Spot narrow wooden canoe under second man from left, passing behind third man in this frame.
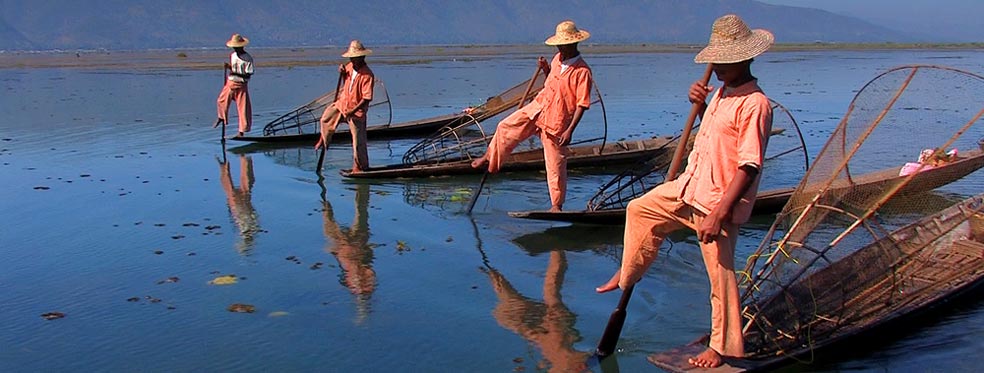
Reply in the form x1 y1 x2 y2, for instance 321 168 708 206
340 136 675 179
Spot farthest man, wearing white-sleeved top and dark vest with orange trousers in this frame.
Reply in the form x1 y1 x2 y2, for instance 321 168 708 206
212 34 253 136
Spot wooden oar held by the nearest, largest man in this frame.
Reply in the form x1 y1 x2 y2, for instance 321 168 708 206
595 64 711 358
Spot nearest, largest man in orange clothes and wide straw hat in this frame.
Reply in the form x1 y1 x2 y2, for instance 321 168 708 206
596 14 774 368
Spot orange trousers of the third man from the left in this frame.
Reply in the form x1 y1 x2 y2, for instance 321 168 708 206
486 110 568 207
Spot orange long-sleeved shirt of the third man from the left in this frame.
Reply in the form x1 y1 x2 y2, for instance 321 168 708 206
523 53 594 136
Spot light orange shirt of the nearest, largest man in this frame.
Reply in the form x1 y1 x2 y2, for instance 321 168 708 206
676 80 772 224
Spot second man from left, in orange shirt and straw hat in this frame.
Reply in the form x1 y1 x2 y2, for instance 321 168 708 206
314 40 376 173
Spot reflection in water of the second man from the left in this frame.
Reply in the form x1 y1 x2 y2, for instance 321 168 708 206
322 184 376 324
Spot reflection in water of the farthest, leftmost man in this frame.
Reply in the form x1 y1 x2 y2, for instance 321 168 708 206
218 154 260 255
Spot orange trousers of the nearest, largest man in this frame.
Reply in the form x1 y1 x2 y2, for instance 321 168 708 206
618 182 745 357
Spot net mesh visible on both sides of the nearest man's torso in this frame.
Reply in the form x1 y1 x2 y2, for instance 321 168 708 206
587 100 810 211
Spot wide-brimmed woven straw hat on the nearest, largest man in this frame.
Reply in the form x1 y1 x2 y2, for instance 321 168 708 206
694 14 775 63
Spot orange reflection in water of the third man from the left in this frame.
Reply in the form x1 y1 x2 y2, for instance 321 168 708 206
484 250 591 372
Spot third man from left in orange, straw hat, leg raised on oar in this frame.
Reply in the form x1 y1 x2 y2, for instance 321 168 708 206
471 20 594 211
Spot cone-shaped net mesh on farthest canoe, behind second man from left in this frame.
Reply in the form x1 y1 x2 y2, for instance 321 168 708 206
263 78 393 136
